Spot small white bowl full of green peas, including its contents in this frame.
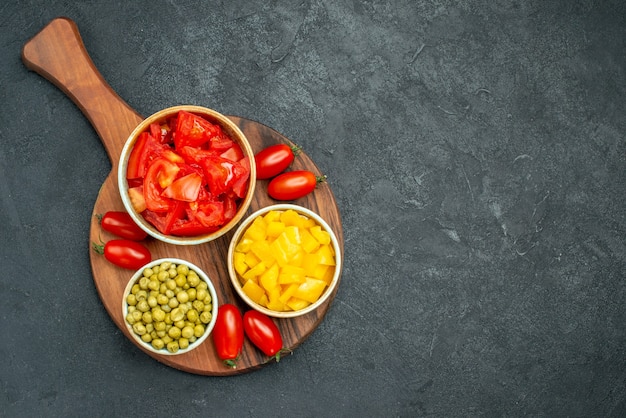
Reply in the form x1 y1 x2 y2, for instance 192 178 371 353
122 258 218 355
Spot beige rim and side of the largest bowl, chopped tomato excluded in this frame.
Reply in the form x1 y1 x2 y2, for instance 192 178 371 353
117 105 256 245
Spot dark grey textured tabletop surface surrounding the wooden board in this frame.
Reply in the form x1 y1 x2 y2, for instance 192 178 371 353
0 0 626 417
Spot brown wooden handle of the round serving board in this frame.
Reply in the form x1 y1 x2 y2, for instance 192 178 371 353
22 17 143 168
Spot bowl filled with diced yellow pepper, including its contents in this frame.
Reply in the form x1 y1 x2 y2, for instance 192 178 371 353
228 204 342 318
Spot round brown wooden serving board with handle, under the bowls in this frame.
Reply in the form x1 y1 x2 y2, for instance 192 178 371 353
22 18 344 375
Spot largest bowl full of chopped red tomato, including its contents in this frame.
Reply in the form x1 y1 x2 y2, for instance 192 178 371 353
118 105 256 245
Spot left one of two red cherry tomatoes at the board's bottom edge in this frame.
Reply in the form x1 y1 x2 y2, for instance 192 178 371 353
211 303 243 369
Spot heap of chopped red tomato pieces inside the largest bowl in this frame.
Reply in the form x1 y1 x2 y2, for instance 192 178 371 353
127 111 251 236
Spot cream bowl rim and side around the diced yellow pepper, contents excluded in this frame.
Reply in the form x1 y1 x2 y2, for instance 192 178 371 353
227 204 342 318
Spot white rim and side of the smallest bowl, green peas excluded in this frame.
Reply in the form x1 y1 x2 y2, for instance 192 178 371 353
122 258 218 355
